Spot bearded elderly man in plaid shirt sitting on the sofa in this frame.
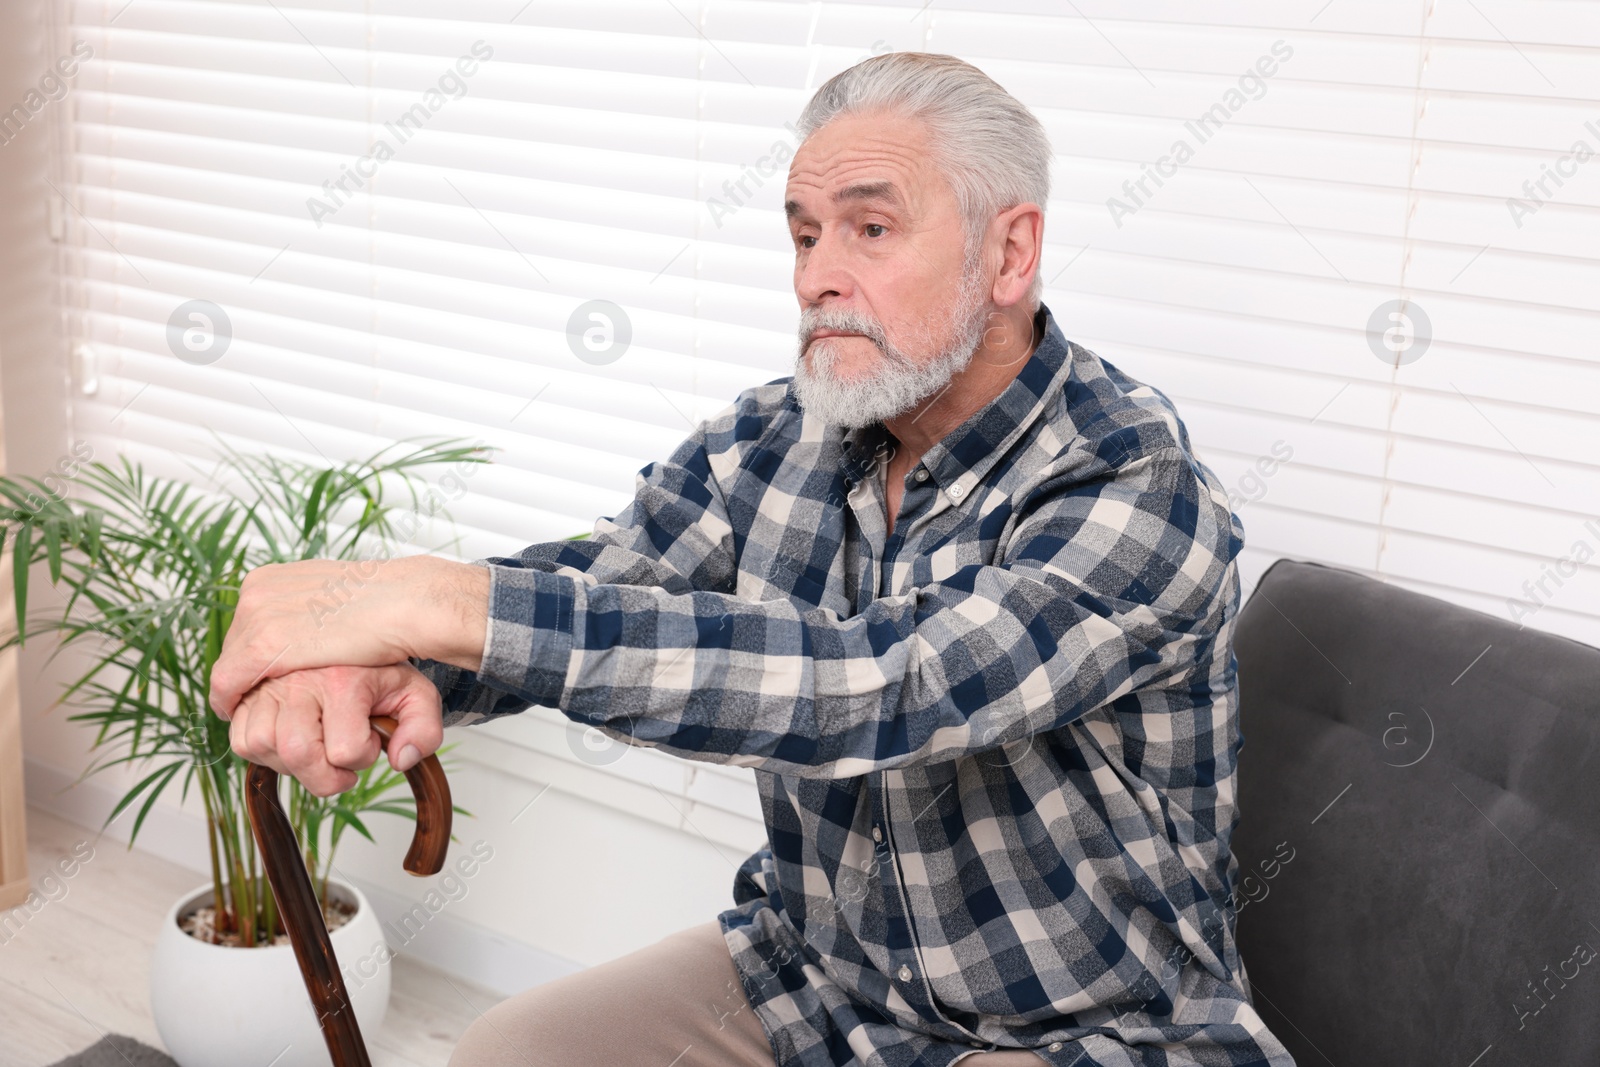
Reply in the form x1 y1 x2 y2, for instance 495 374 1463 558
213 53 1293 1067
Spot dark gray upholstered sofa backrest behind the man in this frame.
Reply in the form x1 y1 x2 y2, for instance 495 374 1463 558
1234 560 1600 1067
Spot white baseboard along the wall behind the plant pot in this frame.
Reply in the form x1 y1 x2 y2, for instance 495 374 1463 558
24 760 582 997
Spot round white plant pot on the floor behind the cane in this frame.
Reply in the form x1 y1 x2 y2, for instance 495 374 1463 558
150 878 389 1067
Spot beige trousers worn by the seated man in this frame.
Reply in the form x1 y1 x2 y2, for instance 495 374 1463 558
450 920 1045 1067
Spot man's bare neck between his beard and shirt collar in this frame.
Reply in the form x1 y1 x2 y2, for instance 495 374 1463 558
883 306 1038 477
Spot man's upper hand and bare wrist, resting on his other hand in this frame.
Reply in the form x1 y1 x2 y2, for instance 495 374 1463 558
211 555 490 718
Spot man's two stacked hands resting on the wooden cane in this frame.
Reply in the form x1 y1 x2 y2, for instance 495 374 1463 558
210 555 490 797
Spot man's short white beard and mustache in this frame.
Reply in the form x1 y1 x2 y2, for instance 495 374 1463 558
794 256 989 429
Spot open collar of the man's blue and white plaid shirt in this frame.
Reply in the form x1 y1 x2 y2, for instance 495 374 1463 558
840 302 1072 502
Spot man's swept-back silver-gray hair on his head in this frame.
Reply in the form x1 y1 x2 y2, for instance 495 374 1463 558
795 51 1051 309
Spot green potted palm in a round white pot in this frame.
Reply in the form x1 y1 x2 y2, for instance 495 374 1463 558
0 440 490 1067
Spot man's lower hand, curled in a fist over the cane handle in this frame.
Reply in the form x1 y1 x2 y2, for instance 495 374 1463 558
227 664 445 797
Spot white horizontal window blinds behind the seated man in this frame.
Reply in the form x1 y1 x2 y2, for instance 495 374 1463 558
62 0 1600 840
